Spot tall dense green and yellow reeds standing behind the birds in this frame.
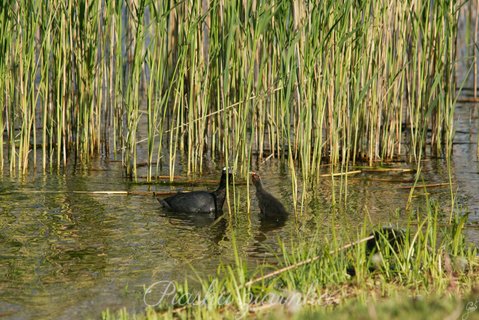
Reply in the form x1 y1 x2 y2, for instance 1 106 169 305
0 0 460 180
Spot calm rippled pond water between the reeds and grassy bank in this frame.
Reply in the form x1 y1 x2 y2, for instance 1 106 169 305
0 125 479 319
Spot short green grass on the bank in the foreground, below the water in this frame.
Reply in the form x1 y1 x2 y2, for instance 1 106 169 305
103 198 479 319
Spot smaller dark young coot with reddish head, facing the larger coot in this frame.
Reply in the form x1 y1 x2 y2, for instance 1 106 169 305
251 172 288 222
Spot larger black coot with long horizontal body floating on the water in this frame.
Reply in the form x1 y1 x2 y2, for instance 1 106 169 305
158 168 233 218
